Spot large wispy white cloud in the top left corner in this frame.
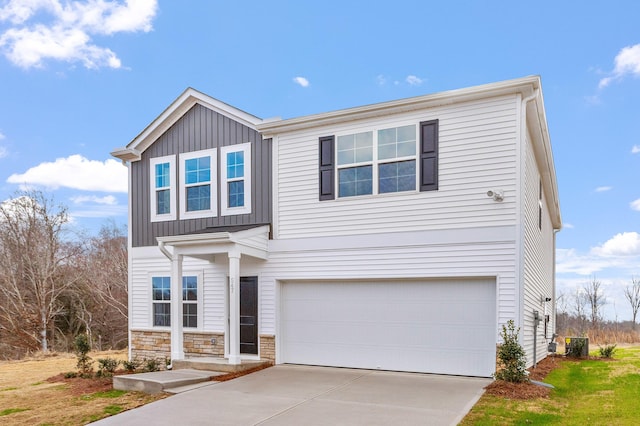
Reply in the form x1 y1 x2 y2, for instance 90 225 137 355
0 0 158 69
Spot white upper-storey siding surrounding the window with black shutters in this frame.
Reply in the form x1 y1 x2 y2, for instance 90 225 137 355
274 95 518 239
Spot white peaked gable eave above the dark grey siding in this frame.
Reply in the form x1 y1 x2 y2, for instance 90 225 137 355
111 87 262 162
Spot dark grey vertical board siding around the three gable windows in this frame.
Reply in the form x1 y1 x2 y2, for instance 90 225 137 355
129 104 272 247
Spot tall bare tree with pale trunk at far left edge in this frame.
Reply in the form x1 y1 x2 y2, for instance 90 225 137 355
0 191 82 352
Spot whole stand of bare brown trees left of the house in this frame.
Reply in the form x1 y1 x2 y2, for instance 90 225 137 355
0 191 128 359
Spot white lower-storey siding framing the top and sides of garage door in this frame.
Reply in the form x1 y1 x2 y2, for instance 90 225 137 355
255 226 517 343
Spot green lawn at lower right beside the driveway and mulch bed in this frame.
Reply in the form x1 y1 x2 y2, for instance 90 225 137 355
461 346 640 426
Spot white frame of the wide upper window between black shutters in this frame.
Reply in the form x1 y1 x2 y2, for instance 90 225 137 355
334 121 420 199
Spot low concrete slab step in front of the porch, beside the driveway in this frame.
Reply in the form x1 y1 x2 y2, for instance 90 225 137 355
113 369 220 393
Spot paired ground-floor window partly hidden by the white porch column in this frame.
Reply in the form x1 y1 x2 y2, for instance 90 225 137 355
151 275 198 328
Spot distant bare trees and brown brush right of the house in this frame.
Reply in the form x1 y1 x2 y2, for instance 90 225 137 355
556 276 640 343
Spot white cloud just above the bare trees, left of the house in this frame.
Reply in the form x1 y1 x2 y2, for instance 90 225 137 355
7 154 127 192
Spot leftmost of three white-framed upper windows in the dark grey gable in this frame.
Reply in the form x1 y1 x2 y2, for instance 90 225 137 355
150 156 176 222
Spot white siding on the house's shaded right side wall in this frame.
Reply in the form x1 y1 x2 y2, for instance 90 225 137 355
520 130 555 365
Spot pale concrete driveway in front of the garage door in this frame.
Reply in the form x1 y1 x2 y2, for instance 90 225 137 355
94 365 491 426
